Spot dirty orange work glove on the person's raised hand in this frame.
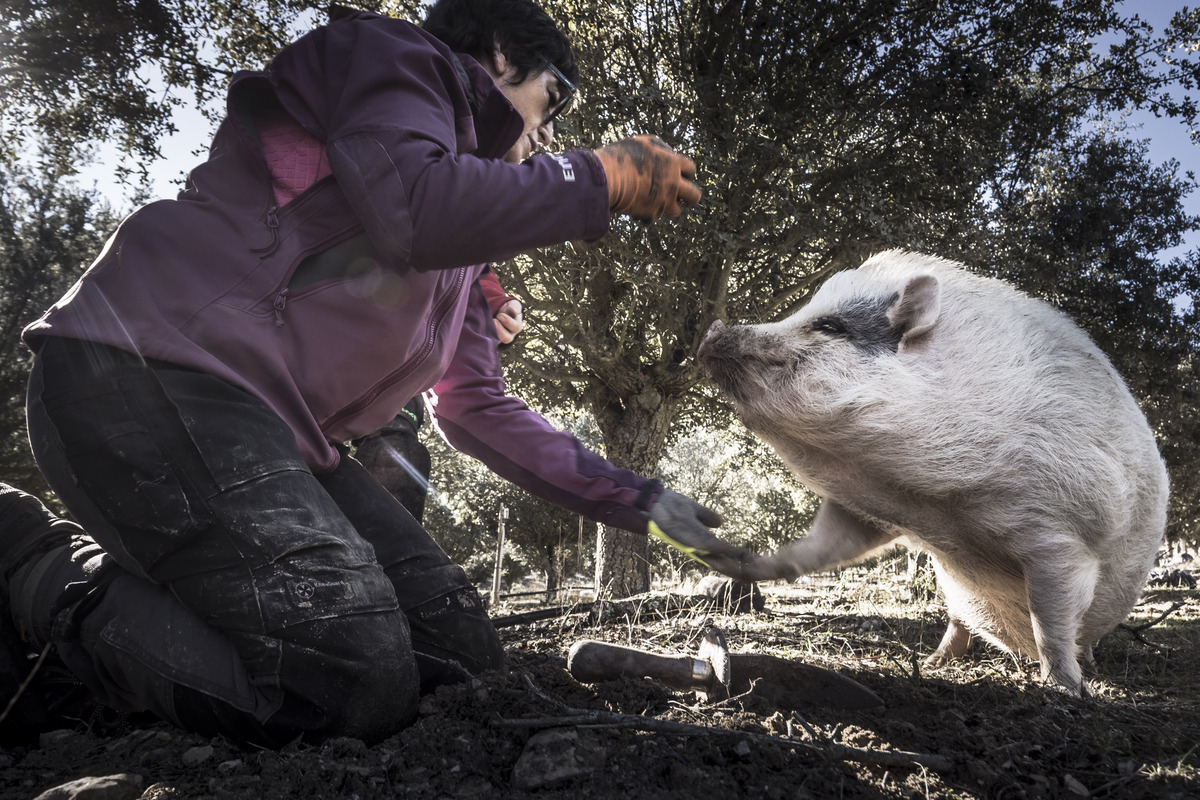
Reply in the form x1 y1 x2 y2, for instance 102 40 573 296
595 133 700 221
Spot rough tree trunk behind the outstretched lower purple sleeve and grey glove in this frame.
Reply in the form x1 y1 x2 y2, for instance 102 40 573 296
594 383 678 597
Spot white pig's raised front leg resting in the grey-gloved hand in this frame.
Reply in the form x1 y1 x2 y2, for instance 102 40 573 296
706 500 896 581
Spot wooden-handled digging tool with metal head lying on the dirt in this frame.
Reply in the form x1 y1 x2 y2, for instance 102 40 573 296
566 627 883 710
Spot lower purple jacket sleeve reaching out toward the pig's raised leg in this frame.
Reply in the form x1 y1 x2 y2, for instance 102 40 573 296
431 283 652 534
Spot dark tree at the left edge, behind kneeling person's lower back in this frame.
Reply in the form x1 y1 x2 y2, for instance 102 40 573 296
0 154 115 498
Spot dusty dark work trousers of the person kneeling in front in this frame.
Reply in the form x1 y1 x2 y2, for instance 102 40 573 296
29 338 503 745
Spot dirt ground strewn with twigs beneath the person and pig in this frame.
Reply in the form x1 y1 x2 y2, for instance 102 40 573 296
0 567 1200 800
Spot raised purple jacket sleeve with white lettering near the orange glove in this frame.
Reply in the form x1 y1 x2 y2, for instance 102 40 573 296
283 13 610 270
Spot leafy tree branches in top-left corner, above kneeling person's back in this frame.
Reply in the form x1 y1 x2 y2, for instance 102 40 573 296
0 0 421 179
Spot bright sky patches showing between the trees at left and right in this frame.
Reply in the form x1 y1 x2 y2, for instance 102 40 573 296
80 7 1200 260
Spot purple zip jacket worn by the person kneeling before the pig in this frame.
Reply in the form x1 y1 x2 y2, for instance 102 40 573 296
24 10 647 533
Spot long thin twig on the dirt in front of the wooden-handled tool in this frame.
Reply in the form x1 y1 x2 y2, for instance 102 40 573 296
492 709 954 772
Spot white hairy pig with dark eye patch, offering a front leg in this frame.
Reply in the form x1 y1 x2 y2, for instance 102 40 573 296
698 251 1168 694
